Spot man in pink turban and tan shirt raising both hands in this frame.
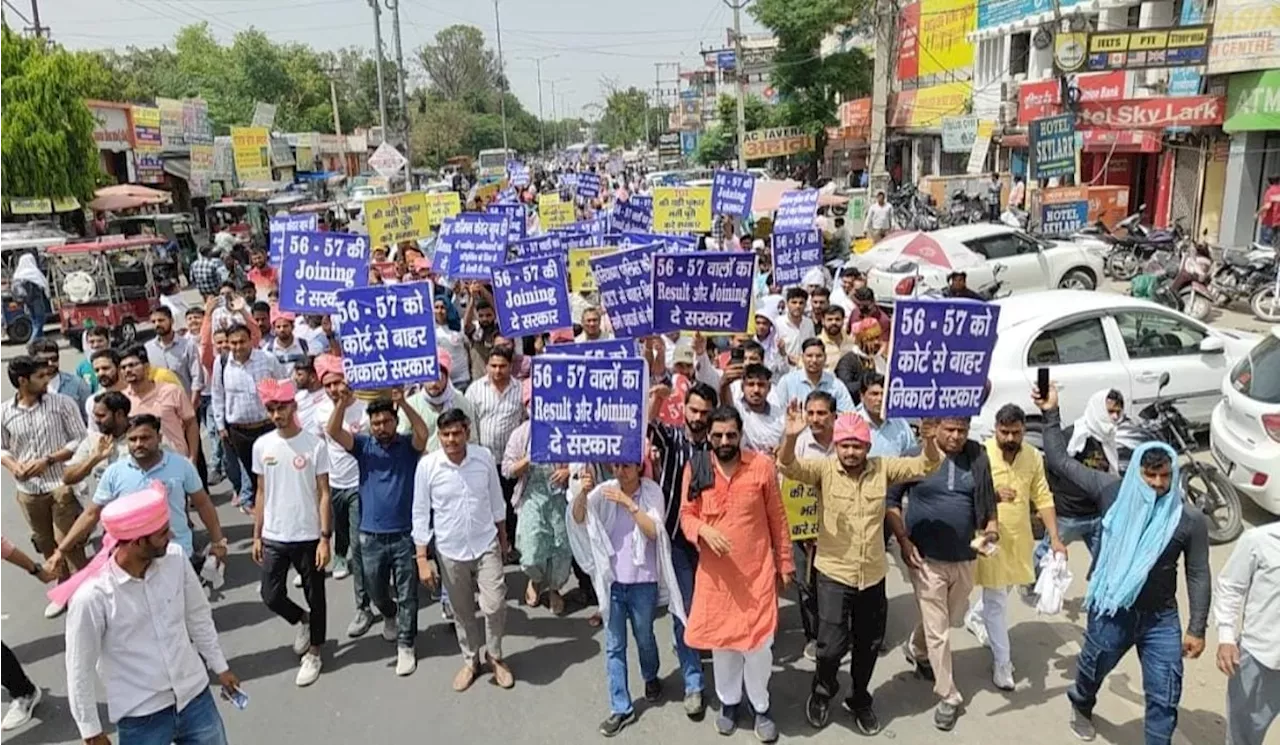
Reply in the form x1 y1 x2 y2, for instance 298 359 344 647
778 403 942 736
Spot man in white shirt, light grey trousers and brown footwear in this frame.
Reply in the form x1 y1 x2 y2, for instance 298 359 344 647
413 408 515 691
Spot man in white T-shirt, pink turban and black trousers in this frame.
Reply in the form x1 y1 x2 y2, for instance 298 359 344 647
253 380 333 686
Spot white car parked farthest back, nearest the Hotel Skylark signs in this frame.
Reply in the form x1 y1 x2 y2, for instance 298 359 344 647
855 223 1103 303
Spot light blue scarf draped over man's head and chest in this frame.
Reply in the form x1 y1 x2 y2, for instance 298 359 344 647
1084 442 1183 616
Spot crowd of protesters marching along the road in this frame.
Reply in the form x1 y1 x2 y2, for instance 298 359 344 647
0 175 1280 745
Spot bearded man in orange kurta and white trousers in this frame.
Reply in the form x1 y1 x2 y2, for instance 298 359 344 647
680 407 795 742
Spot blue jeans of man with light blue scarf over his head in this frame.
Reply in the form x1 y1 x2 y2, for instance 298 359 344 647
1066 608 1183 745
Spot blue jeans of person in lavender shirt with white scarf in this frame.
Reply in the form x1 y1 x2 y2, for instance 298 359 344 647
604 582 658 714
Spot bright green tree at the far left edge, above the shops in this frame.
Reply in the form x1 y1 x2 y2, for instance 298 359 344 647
0 27 104 202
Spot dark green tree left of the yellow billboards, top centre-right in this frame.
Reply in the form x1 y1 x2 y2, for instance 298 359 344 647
750 0 873 174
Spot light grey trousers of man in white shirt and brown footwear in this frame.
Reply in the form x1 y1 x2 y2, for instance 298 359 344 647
439 538 507 663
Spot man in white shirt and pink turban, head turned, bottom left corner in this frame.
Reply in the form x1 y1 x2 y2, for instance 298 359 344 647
67 489 239 745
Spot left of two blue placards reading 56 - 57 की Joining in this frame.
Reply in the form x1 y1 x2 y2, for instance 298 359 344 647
273 232 371 314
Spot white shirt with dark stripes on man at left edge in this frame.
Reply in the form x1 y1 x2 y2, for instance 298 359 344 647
0 393 86 494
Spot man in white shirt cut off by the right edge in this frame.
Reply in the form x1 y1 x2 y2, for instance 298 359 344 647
1213 522 1280 745
